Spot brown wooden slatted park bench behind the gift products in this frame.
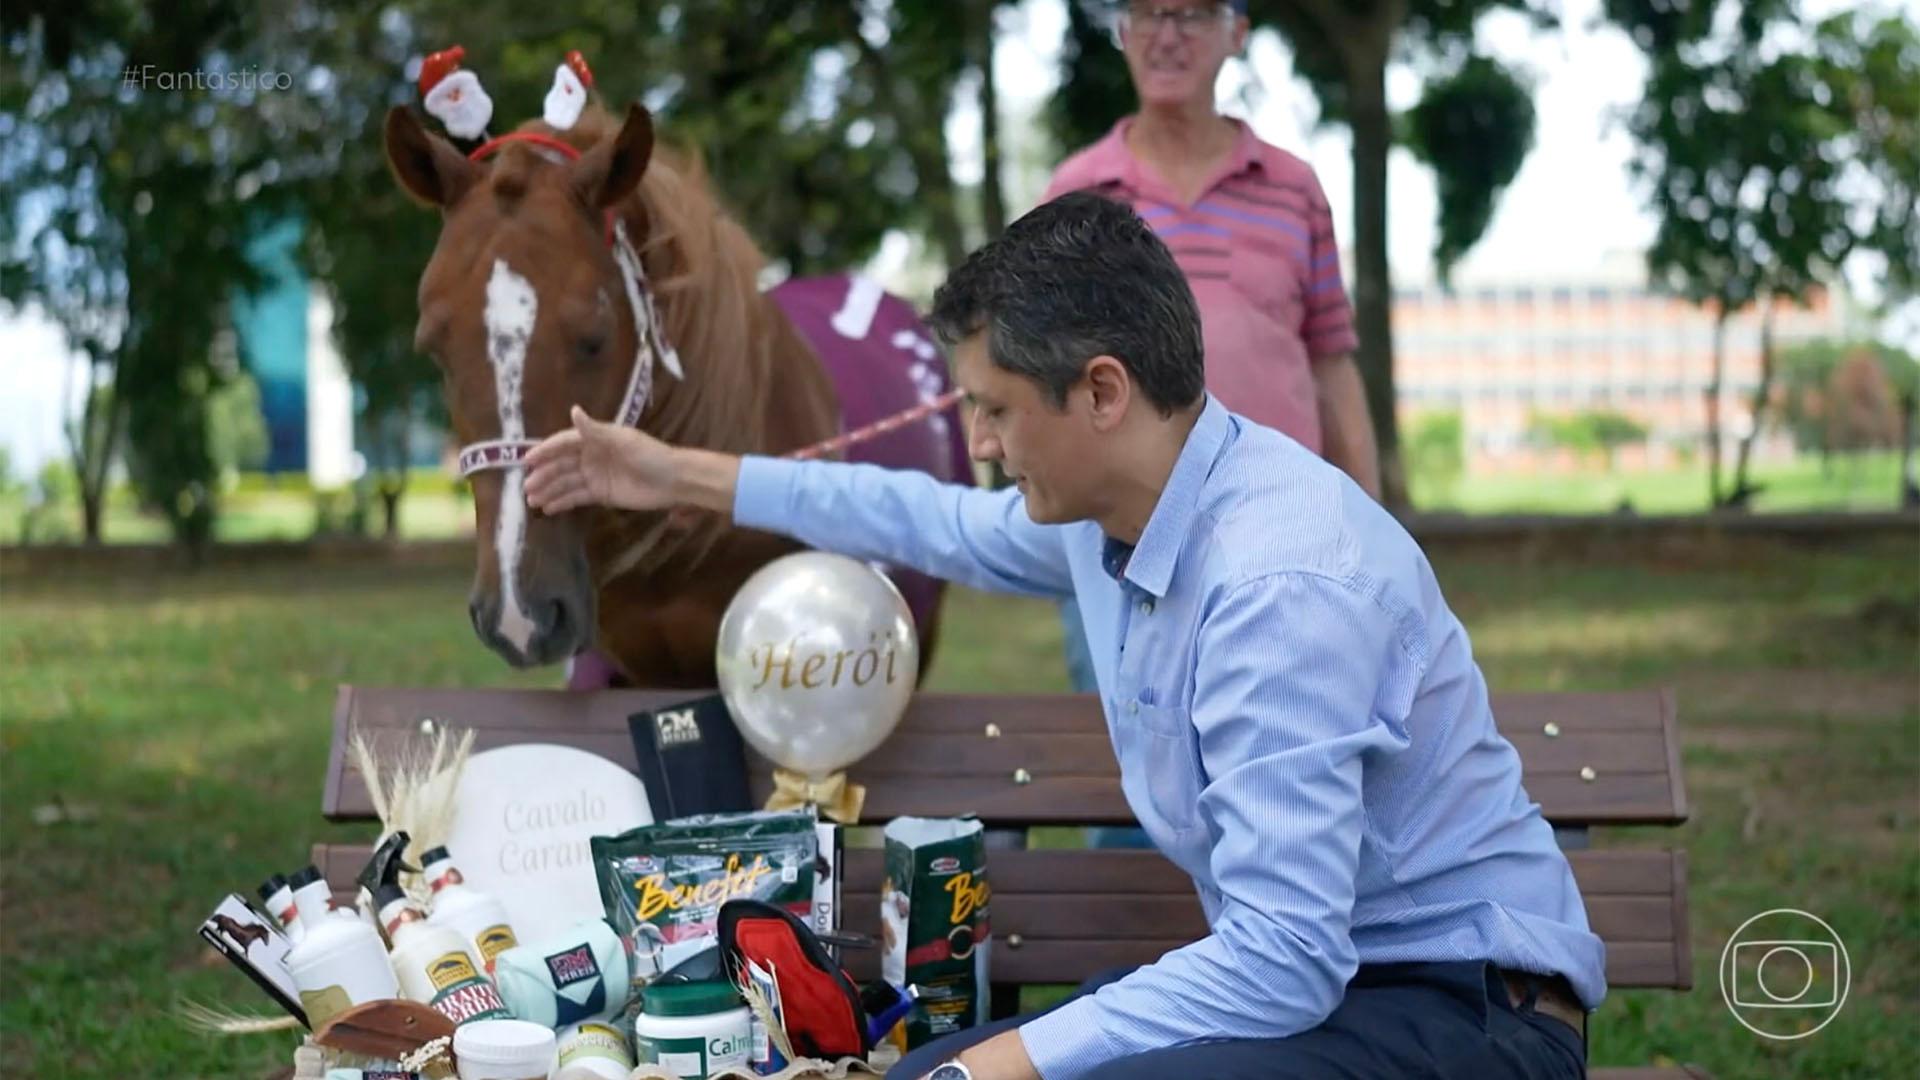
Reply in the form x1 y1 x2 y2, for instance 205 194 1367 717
313 686 1695 1080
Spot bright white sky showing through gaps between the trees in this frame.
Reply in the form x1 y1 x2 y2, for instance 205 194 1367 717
0 0 1920 473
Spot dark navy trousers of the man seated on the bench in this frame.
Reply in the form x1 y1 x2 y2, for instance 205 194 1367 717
887 963 1586 1080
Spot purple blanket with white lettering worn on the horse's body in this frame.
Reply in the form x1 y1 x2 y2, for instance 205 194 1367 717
568 275 973 690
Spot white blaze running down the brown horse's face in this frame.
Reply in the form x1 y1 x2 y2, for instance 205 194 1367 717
486 259 540 653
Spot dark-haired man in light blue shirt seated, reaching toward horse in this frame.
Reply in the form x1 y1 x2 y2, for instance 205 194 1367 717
526 196 1605 1080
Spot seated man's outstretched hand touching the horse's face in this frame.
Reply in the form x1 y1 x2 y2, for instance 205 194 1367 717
526 405 739 513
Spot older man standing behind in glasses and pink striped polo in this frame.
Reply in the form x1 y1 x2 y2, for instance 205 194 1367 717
1043 0 1380 834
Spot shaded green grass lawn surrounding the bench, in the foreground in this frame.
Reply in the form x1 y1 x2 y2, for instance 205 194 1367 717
0 542 1920 1078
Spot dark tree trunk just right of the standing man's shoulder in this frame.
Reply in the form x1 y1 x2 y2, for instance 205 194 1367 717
1346 34 1407 509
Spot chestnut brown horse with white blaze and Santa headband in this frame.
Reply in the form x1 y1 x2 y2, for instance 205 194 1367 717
386 104 966 688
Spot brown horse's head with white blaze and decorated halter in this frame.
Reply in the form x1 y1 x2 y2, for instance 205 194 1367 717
386 106 659 667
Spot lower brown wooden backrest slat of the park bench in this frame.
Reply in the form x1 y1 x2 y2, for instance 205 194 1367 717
313 844 1692 988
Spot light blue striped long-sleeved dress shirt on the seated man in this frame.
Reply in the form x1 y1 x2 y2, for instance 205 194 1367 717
735 398 1605 1080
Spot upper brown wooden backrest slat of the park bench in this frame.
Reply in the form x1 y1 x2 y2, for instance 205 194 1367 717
323 686 1686 826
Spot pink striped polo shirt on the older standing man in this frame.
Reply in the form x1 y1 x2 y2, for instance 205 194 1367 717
1041 117 1356 454
